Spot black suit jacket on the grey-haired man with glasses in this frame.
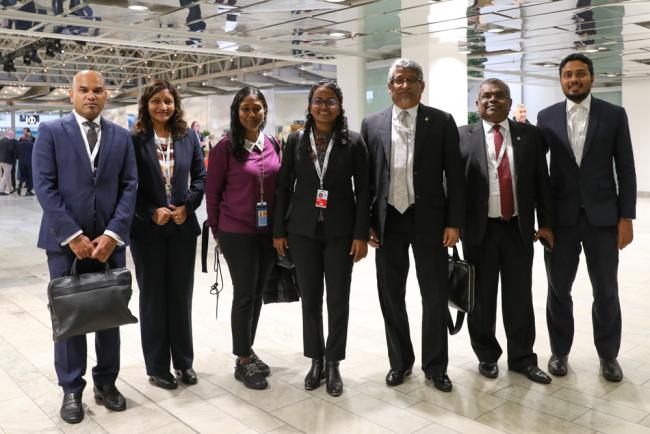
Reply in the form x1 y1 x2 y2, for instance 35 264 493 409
361 104 466 243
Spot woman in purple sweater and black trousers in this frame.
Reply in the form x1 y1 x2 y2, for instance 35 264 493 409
205 87 280 389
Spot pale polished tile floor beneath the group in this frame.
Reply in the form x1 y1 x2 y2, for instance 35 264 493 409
0 197 650 434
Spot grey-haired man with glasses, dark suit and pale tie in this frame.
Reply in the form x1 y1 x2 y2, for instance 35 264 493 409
361 59 465 392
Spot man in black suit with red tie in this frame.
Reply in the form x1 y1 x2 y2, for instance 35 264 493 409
459 78 553 384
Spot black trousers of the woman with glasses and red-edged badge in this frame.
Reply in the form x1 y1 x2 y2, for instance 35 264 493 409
289 228 353 362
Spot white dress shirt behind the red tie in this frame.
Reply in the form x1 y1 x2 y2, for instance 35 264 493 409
483 119 518 218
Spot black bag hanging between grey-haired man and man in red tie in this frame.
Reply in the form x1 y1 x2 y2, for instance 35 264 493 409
447 246 475 335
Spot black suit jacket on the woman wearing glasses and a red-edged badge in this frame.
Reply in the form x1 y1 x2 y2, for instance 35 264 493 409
273 131 369 240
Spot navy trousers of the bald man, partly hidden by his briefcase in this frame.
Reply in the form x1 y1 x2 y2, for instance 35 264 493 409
46 247 126 393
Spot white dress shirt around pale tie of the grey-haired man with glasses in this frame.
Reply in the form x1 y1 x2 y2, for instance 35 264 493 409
388 104 419 214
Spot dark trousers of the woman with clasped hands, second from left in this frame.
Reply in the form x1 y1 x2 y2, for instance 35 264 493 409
131 235 196 375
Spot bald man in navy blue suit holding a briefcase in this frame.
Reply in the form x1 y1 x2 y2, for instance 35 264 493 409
32 71 137 423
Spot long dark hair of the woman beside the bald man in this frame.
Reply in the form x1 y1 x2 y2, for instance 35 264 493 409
135 80 187 140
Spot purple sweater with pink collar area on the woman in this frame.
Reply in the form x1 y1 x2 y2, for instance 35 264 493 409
205 136 280 234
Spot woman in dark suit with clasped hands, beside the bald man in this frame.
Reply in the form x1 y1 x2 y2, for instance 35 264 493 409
131 80 206 389
